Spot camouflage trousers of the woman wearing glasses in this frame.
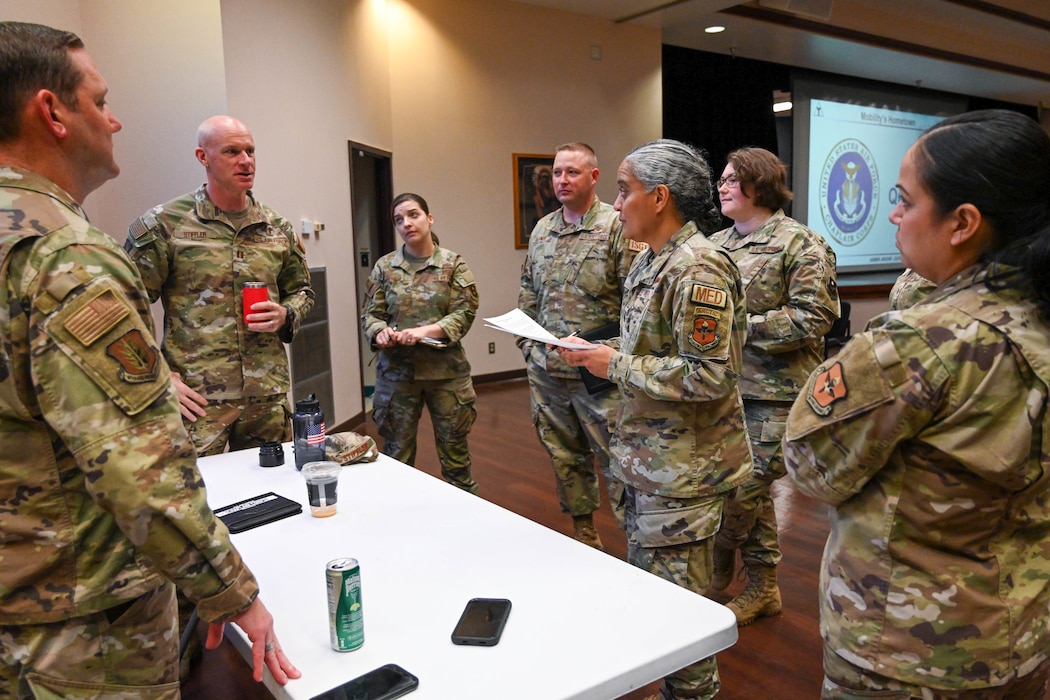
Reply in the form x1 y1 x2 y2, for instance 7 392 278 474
717 401 791 567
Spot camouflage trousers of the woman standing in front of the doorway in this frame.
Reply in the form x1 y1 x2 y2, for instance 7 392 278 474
372 377 478 493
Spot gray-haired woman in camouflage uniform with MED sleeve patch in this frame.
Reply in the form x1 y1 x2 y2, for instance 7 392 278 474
560 140 752 699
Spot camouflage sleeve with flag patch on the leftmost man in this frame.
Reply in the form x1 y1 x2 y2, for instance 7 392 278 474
30 246 258 621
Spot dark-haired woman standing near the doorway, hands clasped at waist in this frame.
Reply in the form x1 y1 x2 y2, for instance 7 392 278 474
361 193 478 493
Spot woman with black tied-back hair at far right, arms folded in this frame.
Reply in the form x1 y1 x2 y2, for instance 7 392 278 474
784 110 1050 700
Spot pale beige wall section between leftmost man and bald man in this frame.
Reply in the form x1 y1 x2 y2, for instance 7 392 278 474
0 0 226 240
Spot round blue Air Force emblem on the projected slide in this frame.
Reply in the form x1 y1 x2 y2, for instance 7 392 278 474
820 139 879 246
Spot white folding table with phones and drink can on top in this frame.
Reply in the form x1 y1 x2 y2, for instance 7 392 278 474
200 445 737 700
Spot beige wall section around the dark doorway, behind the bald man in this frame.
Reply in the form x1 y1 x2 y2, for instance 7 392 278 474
222 0 393 425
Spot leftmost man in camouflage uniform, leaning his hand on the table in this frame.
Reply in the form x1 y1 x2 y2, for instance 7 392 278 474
0 22 299 699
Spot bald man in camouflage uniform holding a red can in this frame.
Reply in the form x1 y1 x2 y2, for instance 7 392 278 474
124 116 314 455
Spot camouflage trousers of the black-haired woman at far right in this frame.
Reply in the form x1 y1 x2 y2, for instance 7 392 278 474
820 646 1050 700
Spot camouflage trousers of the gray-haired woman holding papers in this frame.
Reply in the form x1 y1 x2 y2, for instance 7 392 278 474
624 485 722 700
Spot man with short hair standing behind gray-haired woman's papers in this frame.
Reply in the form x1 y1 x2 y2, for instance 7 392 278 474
517 143 644 549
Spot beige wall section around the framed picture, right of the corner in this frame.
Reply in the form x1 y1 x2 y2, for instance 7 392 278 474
389 0 663 375
